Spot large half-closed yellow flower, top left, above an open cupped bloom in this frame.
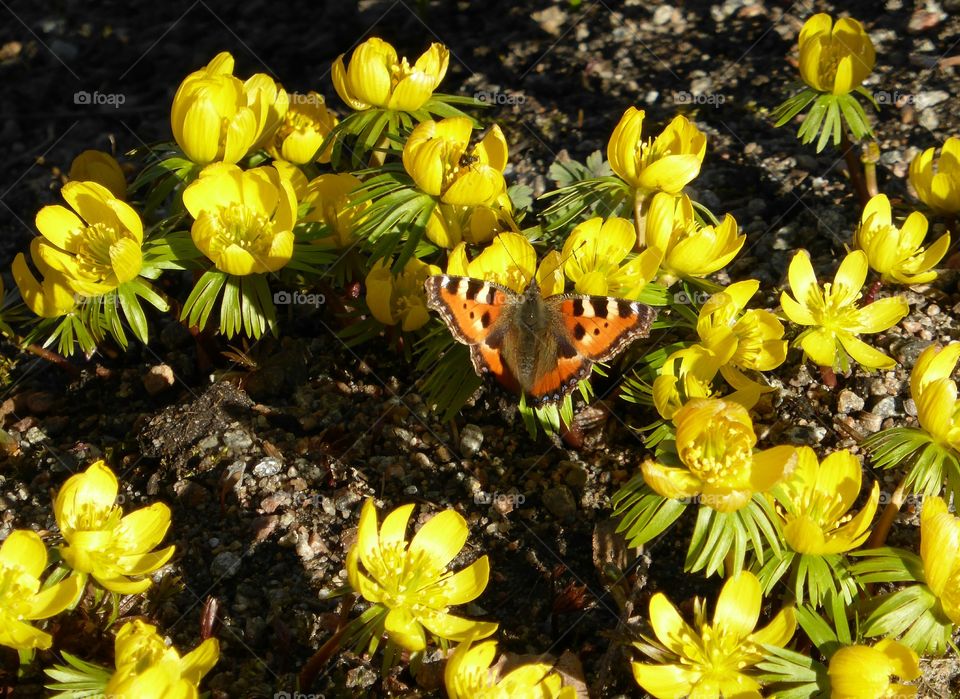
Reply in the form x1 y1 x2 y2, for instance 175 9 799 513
170 51 289 165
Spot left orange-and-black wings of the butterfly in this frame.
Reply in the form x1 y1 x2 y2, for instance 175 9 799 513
424 274 520 391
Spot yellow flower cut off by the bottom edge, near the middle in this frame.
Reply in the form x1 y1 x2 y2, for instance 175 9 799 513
443 639 576 699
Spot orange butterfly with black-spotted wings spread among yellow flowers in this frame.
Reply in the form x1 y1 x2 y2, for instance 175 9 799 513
424 274 657 406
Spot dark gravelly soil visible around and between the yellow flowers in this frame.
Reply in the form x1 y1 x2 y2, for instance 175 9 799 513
0 0 960 697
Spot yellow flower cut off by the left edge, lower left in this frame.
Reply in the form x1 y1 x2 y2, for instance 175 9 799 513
0 529 83 650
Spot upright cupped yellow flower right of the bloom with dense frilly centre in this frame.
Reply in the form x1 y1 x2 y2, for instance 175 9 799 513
774 447 880 556
